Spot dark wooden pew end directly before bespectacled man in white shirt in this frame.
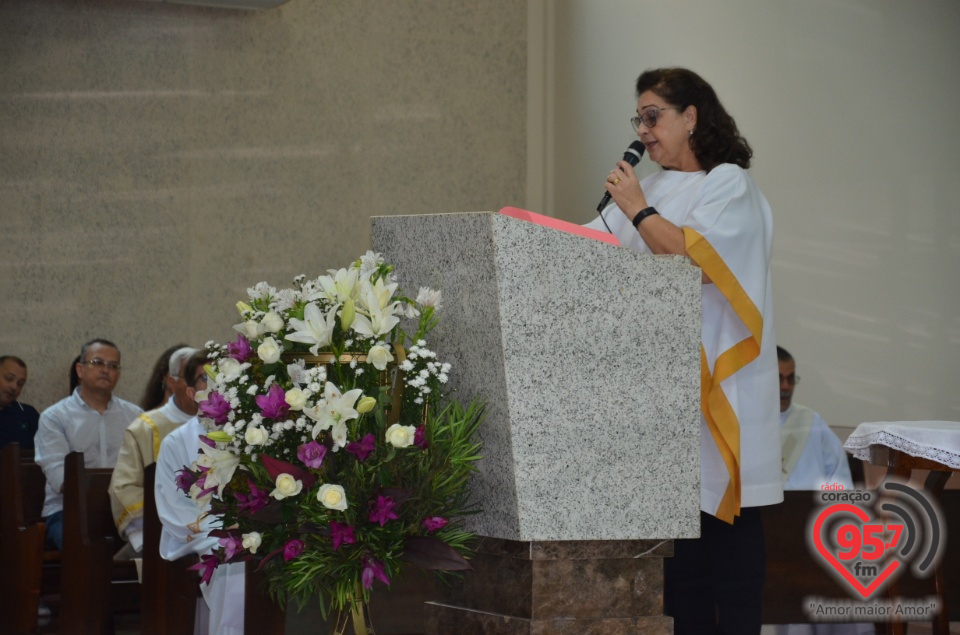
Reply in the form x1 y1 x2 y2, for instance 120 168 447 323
60 452 140 635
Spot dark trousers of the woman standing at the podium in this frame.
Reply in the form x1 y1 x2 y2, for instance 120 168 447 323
663 507 766 635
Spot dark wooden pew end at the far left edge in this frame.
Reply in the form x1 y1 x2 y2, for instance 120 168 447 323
0 443 60 634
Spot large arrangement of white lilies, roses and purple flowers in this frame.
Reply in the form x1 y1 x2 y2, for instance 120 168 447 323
178 252 483 632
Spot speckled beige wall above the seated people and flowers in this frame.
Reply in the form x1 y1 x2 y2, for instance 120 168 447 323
0 0 527 408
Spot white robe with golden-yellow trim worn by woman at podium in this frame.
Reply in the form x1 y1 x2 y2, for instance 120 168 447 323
588 164 783 522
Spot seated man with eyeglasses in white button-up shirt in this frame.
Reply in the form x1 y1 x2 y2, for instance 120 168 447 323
34 339 143 549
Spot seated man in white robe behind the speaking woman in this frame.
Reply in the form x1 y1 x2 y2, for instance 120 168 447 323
777 346 853 490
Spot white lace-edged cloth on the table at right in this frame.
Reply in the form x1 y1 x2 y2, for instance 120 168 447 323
843 421 960 470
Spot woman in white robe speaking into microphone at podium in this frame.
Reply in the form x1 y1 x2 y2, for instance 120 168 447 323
589 68 783 635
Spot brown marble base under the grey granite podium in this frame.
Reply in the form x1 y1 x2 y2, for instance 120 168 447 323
426 538 673 635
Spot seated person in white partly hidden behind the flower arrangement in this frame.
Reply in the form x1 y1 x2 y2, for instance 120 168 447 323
154 360 245 635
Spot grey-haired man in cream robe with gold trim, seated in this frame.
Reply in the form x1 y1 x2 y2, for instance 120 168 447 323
108 346 199 560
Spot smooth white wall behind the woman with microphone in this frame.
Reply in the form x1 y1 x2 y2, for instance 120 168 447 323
531 0 960 435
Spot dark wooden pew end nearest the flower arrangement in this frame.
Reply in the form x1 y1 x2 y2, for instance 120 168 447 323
140 464 199 635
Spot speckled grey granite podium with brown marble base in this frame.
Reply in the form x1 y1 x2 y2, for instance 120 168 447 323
373 212 701 635
